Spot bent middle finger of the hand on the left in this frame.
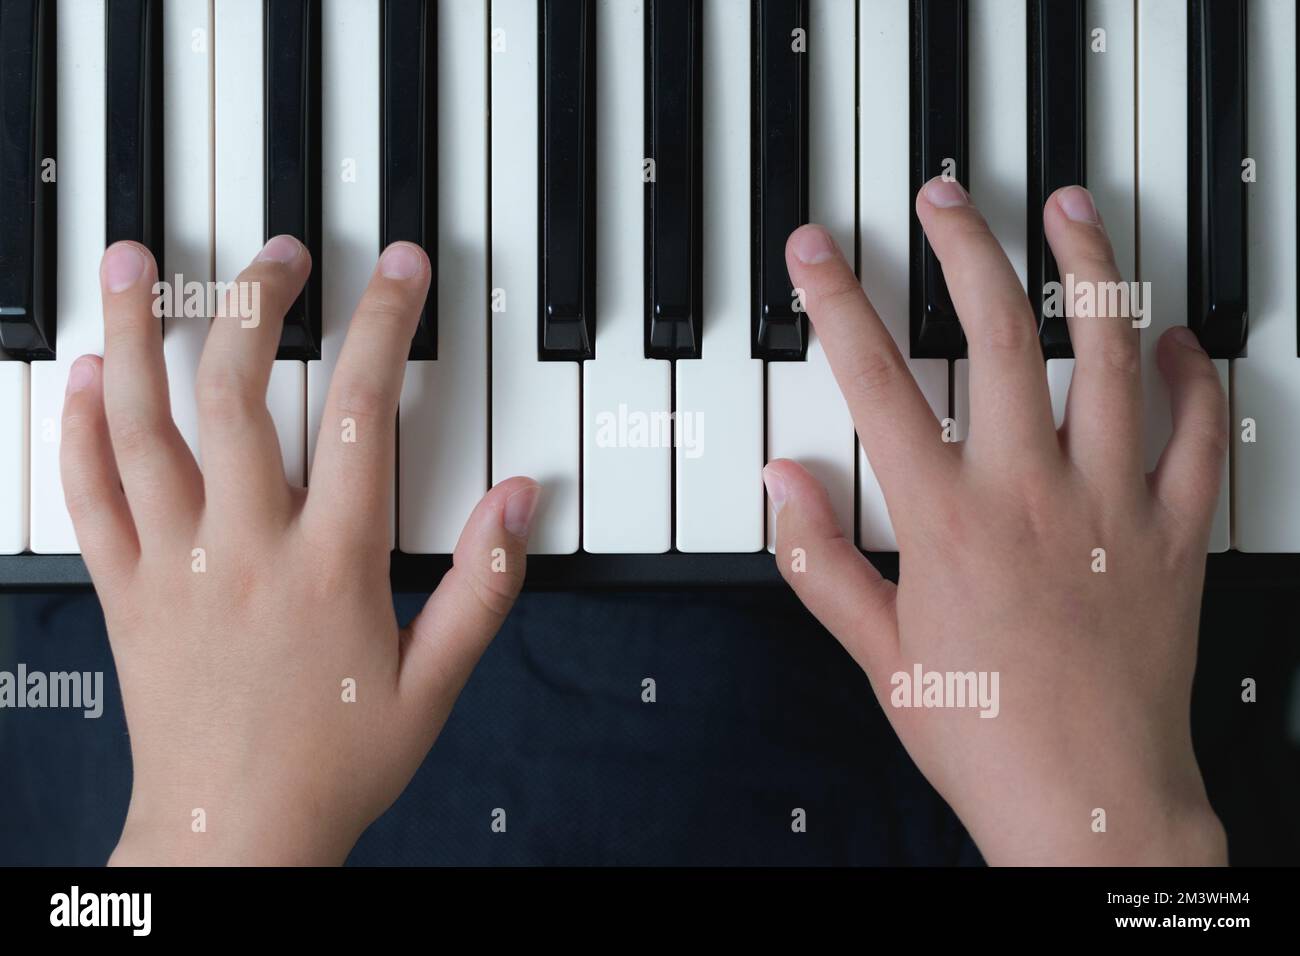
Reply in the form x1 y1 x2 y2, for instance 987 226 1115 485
195 235 312 515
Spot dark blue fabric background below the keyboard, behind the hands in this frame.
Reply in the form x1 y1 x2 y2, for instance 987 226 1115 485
0 591 1300 865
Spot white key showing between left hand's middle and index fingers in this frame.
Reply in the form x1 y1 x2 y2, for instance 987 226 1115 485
314 0 384 540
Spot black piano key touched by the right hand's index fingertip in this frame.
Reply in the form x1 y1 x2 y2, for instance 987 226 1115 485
750 0 809 362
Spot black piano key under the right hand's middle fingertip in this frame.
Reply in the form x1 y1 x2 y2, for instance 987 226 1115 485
911 0 970 359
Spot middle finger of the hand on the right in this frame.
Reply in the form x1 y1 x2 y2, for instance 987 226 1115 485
917 178 1060 460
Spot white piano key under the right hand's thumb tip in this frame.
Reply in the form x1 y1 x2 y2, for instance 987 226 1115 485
767 0 857 550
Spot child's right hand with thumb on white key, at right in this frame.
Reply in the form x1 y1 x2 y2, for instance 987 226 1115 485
764 181 1227 864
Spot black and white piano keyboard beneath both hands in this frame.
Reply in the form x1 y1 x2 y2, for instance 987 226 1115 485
0 0 1300 588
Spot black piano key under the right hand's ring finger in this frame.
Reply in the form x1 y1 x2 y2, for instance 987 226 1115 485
1027 0 1087 359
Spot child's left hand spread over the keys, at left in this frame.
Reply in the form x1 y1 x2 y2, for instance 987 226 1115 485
61 237 538 864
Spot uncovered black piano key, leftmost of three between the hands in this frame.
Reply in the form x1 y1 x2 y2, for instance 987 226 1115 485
537 0 595 362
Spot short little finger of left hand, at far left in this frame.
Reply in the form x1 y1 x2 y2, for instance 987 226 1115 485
59 355 139 582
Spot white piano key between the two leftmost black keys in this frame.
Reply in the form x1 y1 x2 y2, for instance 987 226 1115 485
30 0 105 554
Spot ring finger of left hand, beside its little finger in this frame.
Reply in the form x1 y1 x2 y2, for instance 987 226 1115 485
100 242 203 541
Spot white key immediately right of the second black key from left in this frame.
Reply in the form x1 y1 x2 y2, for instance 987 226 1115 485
159 0 212 455
